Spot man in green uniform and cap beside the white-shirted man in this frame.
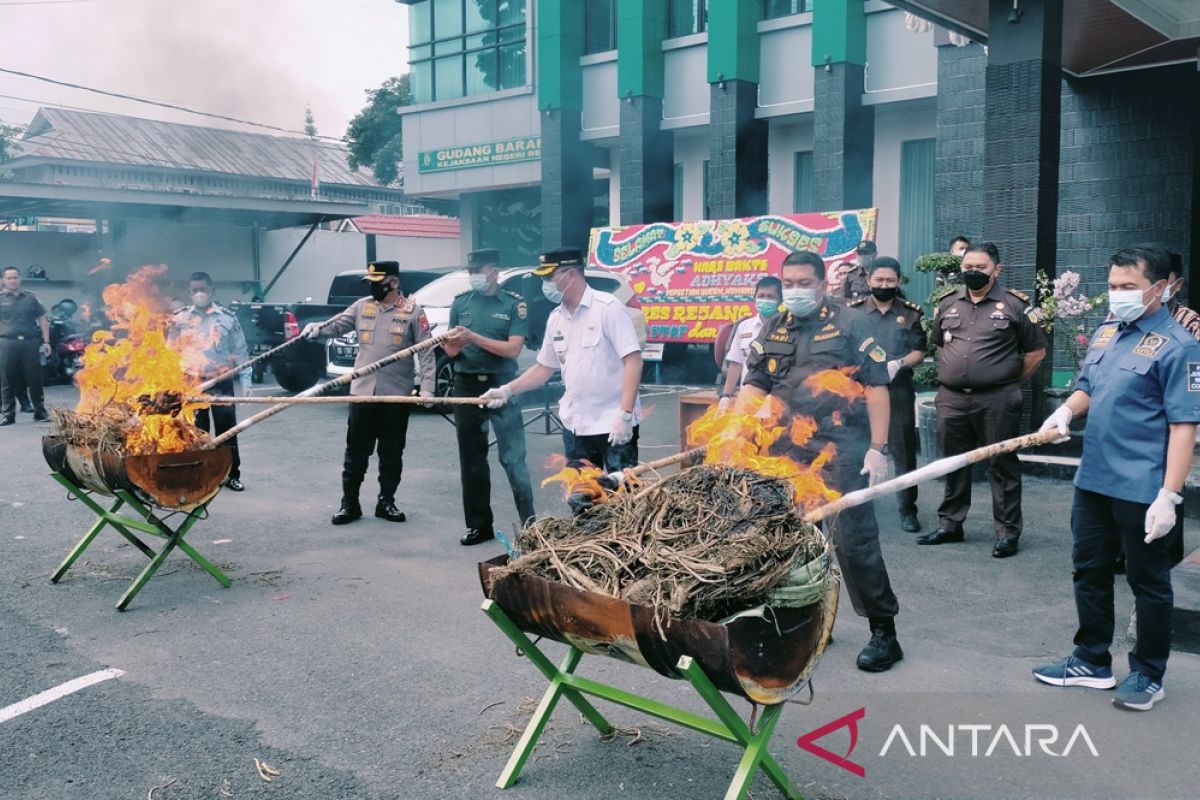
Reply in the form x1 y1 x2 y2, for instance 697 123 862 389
442 249 534 545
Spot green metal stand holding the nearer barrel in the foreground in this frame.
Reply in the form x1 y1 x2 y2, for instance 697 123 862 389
482 600 804 800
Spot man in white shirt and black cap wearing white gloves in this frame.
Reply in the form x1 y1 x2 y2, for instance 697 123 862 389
481 248 642 471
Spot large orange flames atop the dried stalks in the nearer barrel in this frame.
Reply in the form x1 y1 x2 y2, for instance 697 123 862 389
688 395 841 510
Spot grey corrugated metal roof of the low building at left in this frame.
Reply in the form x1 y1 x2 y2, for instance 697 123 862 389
10 108 379 186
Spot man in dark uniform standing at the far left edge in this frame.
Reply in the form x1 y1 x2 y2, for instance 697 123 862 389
0 266 50 425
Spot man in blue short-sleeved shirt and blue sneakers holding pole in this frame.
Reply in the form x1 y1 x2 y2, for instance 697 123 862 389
1033 248 1200 711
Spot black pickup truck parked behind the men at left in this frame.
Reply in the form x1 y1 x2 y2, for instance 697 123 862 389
229 270 446 392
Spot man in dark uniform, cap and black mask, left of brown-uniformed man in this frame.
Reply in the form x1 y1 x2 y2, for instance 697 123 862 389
850 255 925 533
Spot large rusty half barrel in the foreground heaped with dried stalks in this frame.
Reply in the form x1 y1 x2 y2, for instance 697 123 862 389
479 555 838 705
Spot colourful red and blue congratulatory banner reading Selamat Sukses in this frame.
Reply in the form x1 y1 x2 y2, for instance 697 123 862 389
588 209 877 343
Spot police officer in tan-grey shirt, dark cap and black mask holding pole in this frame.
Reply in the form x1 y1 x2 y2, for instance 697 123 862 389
304 261 434 525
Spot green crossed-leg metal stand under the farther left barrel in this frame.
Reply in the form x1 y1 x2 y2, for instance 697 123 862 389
50 473 232 612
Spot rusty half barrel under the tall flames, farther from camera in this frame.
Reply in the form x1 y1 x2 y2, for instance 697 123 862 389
42 435 233 511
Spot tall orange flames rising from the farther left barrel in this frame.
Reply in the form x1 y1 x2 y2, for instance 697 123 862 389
76 266 206 455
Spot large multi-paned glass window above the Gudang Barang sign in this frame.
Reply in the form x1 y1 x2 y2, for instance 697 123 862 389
408 0 527 103
